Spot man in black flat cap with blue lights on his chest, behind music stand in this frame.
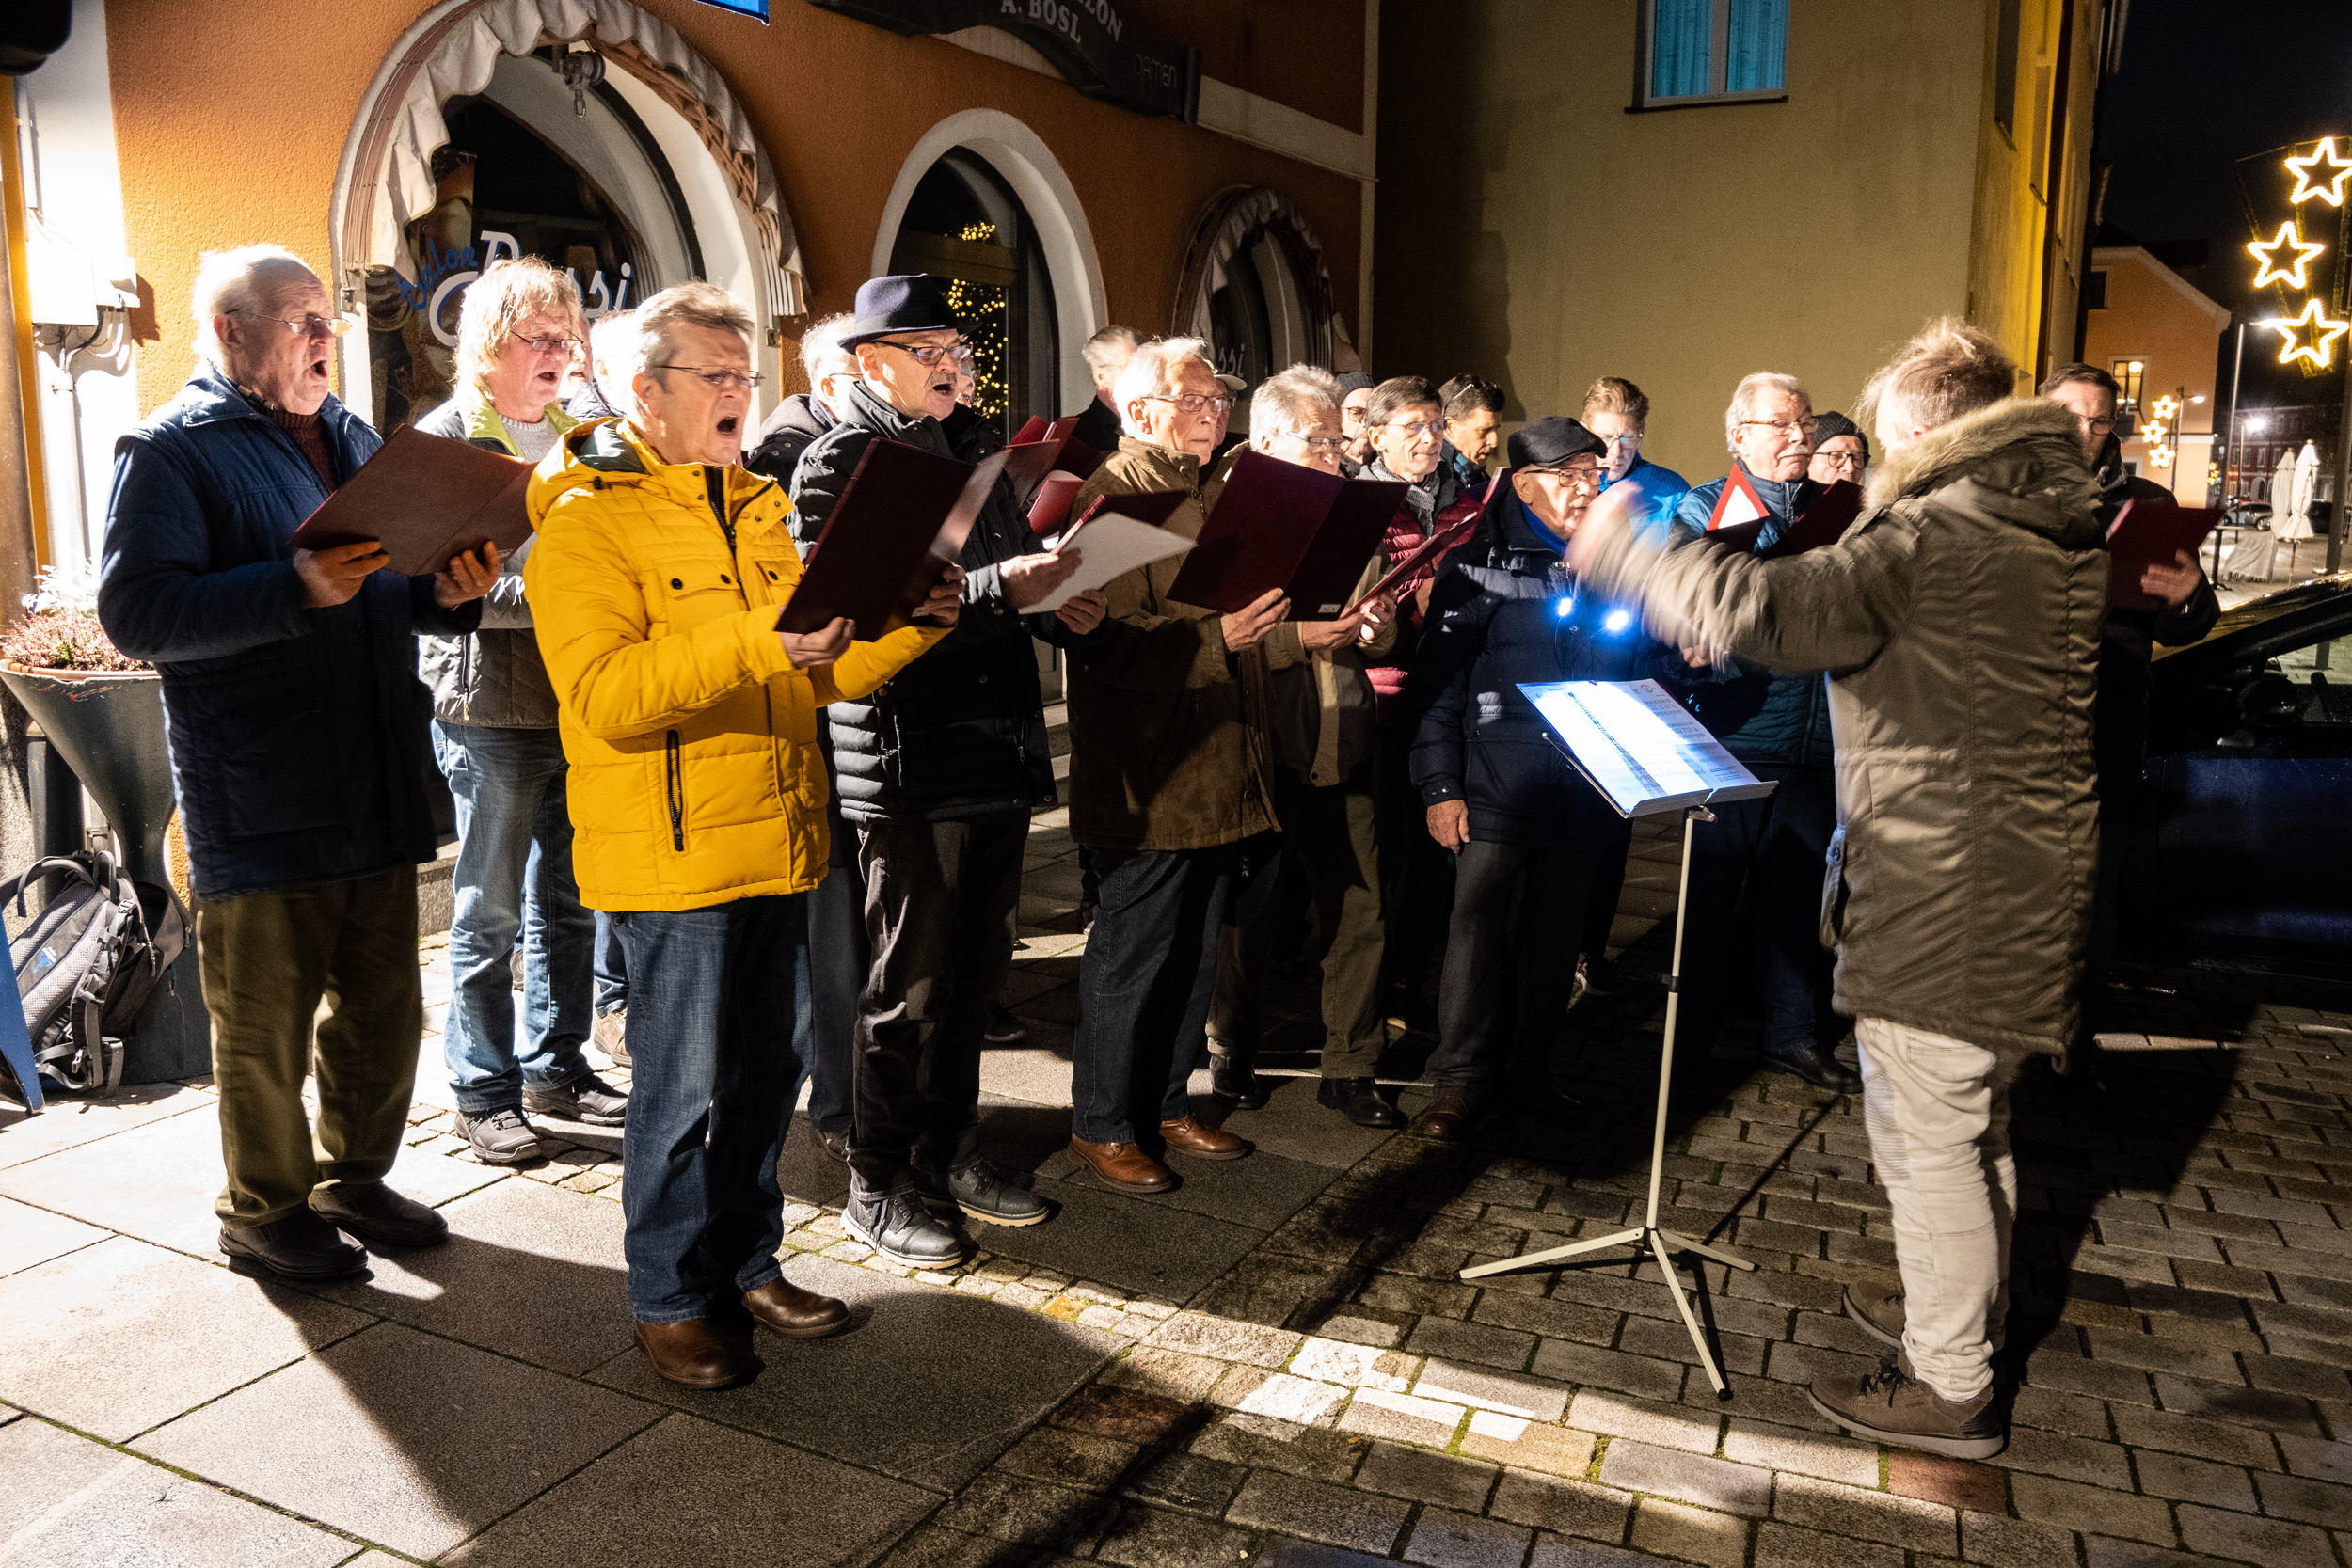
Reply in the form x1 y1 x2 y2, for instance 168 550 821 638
1406 416 1684 1138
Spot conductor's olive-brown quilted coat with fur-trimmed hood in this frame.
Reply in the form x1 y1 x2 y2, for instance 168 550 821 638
1588 400 2107 1051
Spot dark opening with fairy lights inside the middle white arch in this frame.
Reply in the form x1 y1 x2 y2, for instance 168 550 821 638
889 148 1061 439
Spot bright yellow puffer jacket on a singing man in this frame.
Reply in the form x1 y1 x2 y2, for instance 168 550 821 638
522 419 946 910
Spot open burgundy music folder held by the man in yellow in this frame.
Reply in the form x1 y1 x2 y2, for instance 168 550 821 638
776 439 1005 641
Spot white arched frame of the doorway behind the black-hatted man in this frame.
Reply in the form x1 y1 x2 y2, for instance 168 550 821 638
870 108 1110 416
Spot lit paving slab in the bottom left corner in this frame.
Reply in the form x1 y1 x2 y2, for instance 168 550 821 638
0 1420 355 1568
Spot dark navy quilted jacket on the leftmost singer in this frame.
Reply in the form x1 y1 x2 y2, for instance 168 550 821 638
99 364 483 898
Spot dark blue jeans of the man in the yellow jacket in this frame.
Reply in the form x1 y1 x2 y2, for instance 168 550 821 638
612 894 809 1323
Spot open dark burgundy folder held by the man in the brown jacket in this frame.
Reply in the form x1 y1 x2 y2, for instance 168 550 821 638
1169 451 1406 621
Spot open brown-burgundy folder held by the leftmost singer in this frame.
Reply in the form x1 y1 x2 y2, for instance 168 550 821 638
290 425 532 576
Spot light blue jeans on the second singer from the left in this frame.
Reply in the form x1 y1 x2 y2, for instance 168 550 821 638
433 721 596 1117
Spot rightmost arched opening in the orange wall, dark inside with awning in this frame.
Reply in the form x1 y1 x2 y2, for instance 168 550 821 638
1169 188 1359 428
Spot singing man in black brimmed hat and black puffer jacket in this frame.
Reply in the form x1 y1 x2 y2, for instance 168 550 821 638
793 275 1104 1267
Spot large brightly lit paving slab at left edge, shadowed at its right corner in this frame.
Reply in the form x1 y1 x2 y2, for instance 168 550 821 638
0 1237 370 1441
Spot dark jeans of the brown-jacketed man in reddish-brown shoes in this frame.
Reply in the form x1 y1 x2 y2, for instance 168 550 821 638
1071 844 1237 1143
